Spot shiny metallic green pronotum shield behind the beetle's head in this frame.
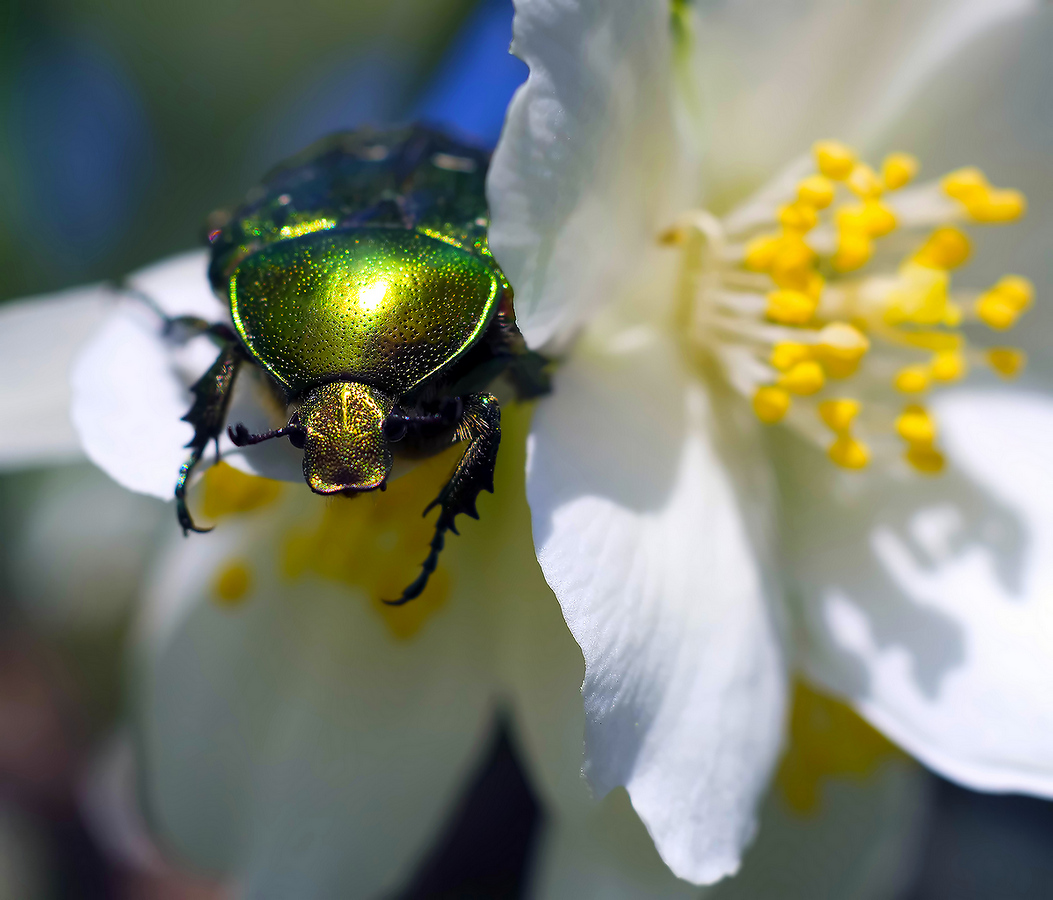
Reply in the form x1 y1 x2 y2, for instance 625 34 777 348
231 227 505 395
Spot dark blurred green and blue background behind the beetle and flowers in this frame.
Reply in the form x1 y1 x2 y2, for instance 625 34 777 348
0 0 1053 900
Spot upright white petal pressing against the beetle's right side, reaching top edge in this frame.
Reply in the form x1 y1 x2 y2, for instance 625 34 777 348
488 0 695 347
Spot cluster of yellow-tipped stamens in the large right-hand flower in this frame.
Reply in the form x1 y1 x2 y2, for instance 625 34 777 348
662 141 1033 474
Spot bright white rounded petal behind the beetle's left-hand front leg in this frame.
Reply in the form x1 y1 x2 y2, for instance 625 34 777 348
73 253 302 498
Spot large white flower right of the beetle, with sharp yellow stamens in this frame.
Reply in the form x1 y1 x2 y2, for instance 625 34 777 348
490 0 1053 882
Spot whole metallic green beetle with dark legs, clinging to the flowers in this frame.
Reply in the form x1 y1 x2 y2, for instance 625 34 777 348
167 126 548 604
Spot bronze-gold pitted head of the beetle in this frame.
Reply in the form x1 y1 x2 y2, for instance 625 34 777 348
297 381 395 494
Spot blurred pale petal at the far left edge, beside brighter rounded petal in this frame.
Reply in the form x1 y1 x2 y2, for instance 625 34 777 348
0 285 114 466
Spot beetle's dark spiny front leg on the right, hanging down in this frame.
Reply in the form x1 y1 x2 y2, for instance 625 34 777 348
384 394 501 606
